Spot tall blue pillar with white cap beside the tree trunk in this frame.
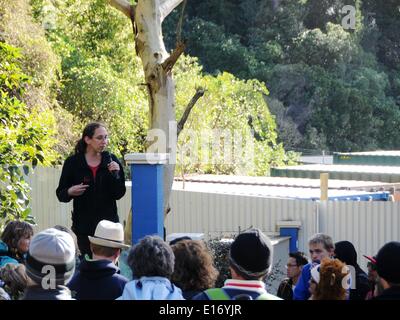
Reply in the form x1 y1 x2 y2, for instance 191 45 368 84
125 153 168 244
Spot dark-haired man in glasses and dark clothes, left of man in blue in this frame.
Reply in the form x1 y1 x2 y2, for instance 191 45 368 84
277 252 308 300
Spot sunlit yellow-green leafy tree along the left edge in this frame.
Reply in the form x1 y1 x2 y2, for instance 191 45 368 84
0 0 71 229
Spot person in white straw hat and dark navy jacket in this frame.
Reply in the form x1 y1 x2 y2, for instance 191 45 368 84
68 220 129 300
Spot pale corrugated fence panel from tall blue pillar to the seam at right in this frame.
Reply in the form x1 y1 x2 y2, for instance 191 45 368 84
166 190 316 250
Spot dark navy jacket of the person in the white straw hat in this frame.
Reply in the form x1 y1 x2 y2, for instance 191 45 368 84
68 259 129 300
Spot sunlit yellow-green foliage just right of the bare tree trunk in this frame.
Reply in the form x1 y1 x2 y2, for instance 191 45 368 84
175 56 293 175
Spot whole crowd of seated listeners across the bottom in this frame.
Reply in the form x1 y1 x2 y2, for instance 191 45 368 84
0 220 400 300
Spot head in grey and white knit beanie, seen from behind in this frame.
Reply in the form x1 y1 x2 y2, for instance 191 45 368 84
26 228 75 285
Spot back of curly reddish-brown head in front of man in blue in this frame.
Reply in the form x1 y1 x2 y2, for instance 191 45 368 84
311 258 350 300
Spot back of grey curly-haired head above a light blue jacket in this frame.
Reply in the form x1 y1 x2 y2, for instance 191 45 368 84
128 236 175 279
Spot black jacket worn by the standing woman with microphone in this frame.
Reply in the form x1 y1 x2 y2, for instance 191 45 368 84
56 152 126 235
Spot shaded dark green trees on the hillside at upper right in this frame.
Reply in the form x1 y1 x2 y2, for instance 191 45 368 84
164 0 400 151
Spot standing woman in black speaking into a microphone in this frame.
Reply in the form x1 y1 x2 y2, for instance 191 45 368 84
56 122 126 256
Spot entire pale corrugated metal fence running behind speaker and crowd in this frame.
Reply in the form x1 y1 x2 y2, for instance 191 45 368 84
28 167 400 266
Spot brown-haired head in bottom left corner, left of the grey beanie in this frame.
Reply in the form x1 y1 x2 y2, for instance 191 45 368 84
0 263 29 299
